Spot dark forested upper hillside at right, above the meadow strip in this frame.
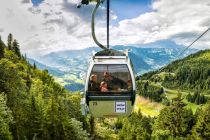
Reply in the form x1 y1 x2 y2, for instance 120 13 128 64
139 50 210 94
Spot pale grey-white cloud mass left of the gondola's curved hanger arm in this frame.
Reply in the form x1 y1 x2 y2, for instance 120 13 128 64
0 0 101 57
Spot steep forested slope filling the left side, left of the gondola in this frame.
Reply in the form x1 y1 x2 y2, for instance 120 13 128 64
0 34 89 140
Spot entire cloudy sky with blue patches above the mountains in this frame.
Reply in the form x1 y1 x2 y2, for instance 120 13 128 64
0 0 210 58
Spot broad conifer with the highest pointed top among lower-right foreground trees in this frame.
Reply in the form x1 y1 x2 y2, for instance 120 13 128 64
152 95 193 139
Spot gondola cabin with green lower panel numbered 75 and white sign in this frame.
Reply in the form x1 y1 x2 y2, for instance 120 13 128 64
85 50 136 117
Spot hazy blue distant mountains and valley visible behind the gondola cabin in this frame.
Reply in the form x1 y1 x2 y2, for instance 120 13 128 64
28 41 197 90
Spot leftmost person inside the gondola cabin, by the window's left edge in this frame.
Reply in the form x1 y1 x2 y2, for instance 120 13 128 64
88 74 100 91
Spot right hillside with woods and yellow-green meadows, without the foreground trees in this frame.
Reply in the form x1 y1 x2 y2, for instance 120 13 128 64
136 50 210 116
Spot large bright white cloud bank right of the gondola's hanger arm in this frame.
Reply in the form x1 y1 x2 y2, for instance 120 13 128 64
108 0 210 48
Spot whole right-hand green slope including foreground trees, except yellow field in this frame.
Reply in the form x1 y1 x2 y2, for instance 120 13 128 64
121 50 210 140
